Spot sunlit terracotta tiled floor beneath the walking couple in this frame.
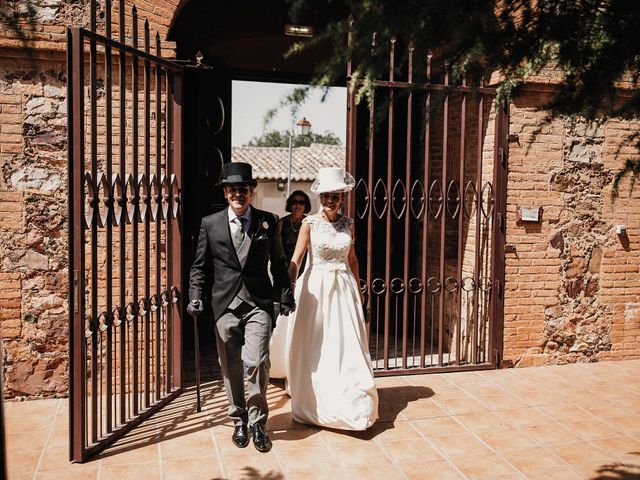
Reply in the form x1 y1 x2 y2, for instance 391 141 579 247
7 360 640 480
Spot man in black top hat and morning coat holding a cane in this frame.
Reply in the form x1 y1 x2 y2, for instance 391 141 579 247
187 162 295 452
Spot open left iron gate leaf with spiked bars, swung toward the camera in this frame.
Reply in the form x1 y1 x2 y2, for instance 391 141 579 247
67 0 182 462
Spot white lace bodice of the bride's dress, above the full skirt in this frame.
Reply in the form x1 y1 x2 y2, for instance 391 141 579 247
302 215 353 267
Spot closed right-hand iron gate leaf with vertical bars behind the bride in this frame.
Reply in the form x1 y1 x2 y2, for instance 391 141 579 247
347 39 508 375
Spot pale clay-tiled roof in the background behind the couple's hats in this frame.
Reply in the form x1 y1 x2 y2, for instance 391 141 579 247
231 143 345 181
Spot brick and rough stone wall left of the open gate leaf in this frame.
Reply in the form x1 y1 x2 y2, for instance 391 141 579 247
0 0 177 396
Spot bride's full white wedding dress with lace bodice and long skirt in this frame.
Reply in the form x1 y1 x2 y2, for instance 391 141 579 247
270 216 378 430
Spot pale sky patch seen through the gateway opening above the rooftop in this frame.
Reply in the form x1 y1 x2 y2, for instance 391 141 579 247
231 81 347 147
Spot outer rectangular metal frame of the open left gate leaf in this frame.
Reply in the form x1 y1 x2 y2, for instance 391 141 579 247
67 7 186 462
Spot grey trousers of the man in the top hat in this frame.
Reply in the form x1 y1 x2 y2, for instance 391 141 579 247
216 297 271 426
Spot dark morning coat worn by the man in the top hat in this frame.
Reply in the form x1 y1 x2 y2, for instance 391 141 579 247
189 206 294 323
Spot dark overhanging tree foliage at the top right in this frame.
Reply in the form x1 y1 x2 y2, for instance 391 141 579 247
290 0 640 195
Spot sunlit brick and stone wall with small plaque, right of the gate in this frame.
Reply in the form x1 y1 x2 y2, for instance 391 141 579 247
504 88 640 366
